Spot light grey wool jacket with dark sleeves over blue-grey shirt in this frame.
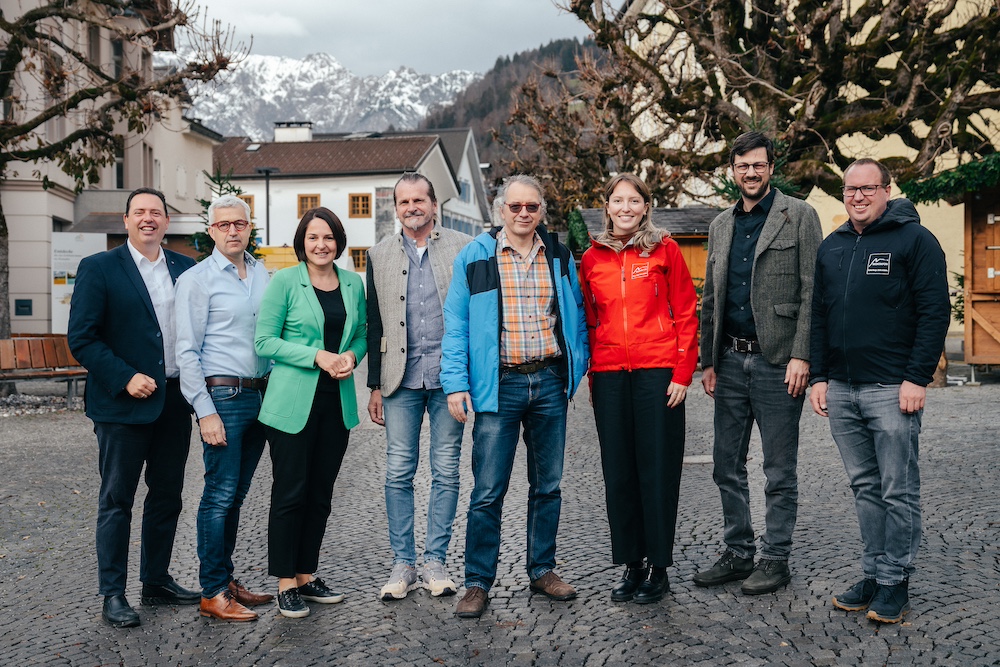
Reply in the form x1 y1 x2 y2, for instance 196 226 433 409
368 224 472 396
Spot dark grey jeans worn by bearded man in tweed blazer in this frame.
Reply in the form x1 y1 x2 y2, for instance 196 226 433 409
712 349 805 560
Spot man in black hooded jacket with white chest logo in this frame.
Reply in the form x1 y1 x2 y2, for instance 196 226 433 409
809 159 951 623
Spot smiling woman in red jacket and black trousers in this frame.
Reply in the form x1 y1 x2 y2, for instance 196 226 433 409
581 174 698 603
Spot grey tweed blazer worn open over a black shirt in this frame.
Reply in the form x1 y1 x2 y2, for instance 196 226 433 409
701 190 823 368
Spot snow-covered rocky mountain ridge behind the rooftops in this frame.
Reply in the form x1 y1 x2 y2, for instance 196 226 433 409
170 53 481 141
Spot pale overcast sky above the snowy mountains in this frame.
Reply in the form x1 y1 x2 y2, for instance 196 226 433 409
198 0 590 75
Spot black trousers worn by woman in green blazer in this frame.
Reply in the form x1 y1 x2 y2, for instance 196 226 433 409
267 391 350 577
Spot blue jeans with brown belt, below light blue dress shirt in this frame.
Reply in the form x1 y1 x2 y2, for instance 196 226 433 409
198 387 264 598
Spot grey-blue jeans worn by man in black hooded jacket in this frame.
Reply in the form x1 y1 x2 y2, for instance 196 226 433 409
827 380 922 586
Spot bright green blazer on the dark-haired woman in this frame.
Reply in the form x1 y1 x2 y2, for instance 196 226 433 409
254 262 368 433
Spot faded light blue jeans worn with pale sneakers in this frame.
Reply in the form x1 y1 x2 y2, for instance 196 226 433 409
382 387 465 565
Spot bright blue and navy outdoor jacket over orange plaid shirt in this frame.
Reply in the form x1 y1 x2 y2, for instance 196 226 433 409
441 225 588 412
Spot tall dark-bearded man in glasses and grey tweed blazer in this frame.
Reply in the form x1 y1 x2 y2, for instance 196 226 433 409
694 132 823 595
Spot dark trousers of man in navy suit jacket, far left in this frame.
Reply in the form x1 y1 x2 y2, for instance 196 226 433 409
94 381 191 595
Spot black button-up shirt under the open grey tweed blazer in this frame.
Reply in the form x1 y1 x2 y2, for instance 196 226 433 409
723 188 775 338
